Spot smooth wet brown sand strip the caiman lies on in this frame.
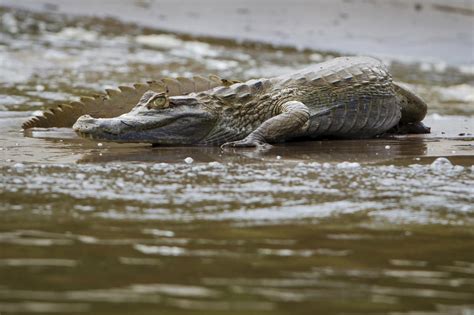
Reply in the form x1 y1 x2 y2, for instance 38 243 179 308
0 112 474 166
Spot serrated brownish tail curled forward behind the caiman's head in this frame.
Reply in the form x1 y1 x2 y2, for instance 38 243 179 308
22 75 228 130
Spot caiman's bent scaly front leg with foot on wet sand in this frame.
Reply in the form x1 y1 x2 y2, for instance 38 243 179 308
221 101 309 148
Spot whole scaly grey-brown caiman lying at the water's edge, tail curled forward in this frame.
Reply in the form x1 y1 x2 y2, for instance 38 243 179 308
23 57 430 147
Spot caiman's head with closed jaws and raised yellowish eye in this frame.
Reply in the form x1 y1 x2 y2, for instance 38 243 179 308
73 91 216 145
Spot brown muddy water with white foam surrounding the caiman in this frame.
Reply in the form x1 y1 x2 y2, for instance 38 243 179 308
0 5 474 315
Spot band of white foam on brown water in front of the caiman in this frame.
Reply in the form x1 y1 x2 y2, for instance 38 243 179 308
0 162 474 224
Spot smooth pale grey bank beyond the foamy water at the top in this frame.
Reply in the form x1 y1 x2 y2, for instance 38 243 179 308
2 0 474 66
